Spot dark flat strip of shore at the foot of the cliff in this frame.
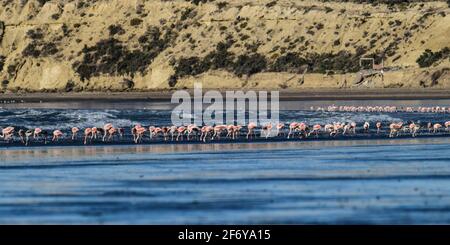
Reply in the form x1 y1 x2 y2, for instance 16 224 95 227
0 89 450 103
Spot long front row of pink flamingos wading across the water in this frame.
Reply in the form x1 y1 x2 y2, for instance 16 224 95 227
0 121 450 145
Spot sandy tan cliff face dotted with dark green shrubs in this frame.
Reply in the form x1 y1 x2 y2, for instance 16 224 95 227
0 0 450 91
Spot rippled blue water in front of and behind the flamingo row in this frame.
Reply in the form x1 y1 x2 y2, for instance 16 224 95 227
0 100 450 224
